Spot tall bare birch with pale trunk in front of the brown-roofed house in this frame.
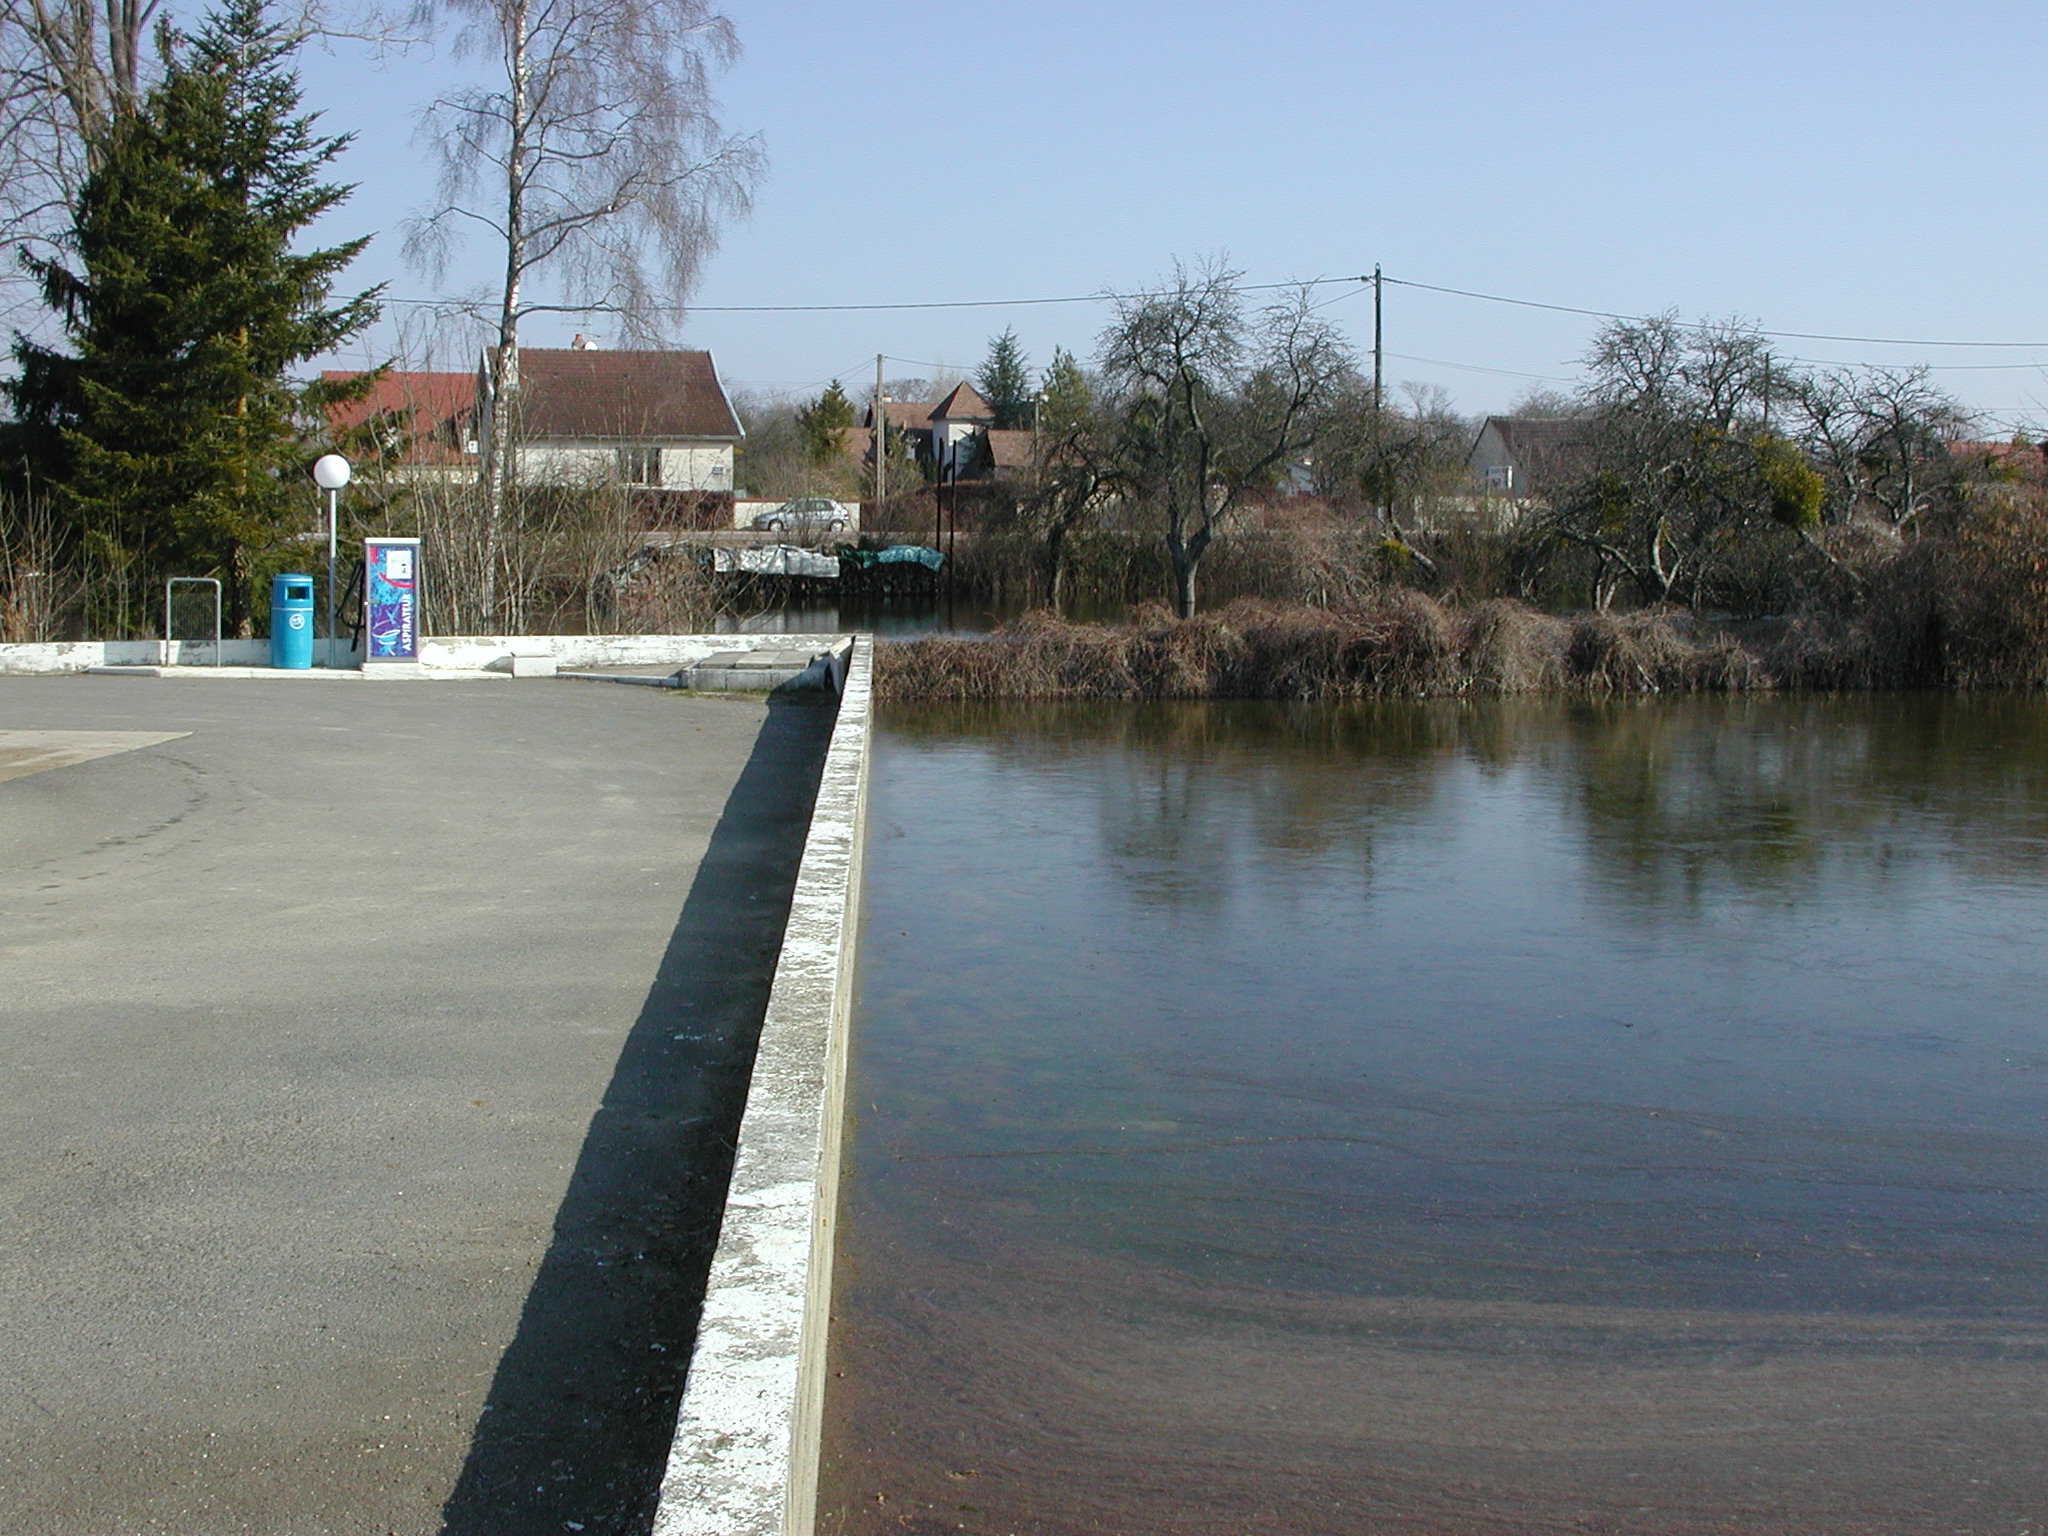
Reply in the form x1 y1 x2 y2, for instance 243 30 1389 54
406 0 764 630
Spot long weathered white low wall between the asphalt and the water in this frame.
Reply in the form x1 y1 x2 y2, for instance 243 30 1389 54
653 635 874 1536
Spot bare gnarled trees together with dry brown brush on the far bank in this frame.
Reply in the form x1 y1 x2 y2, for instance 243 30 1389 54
879 286 2048 698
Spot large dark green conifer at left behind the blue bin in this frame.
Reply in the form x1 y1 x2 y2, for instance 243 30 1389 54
8 0 377 623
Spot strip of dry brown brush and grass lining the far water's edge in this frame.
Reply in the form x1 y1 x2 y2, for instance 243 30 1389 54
877 494 2048 700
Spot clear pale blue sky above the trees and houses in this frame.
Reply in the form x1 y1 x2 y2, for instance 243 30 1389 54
305 0 2048 426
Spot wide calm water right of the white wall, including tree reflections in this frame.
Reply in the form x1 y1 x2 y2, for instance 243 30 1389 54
821 696 2048 1536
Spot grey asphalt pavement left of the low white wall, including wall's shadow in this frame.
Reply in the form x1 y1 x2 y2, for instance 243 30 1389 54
0 678 829 1536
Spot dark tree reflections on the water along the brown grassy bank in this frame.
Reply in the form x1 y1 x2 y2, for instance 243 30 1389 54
893 696 2048 915
